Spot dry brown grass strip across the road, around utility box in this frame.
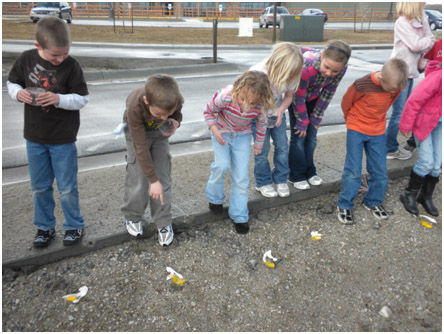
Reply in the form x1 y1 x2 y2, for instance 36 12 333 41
2 20 442 45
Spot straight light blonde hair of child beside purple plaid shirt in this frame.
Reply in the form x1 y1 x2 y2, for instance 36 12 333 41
265 42 304 94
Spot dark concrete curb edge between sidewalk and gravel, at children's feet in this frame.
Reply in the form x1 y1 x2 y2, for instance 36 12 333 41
2 165 411 272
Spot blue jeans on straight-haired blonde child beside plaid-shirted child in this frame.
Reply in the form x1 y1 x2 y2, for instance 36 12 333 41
252 114 290 187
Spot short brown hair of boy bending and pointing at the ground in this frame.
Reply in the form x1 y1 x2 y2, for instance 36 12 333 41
145 74 183 111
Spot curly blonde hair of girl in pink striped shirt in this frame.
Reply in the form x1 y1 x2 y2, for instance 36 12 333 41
231 71 274 113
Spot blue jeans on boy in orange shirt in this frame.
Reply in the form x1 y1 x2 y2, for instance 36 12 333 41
338 130 388 210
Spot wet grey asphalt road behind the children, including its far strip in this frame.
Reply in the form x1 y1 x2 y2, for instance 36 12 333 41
2 41 424 168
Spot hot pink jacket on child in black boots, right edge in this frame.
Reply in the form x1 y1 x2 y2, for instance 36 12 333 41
399 60 442 141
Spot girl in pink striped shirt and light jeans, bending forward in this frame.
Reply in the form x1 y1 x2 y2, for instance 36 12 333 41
204 71 273 234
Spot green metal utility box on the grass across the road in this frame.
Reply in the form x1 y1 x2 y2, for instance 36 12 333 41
279 14 324 42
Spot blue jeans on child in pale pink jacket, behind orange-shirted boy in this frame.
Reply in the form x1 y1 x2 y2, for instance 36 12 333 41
385 79 413 153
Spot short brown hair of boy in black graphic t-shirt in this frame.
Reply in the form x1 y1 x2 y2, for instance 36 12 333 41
35 16 71 49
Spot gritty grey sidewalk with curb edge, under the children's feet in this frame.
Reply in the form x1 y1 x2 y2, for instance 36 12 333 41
2 132 417 268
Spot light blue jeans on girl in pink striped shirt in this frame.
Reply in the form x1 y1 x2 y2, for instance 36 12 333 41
206 132 251 223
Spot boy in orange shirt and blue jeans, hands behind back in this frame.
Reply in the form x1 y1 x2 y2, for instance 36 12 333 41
337 58 408 225
